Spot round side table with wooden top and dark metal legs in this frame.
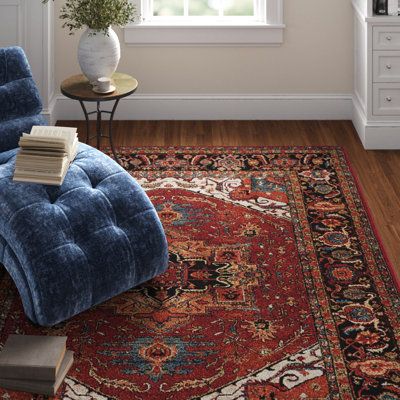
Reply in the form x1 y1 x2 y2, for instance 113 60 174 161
61 72 138 163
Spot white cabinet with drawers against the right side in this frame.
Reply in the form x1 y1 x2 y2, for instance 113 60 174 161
353 0 400 149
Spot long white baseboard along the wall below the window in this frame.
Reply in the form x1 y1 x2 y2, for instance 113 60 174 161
52 94 352 120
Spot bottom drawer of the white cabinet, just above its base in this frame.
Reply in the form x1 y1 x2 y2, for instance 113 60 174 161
372 83 400 117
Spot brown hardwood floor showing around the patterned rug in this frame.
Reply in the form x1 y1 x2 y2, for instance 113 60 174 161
59 121 400 277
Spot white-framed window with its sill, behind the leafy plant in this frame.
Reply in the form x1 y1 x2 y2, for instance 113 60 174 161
125 0 284 46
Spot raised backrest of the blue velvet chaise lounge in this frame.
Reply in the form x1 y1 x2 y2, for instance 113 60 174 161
0 47 46 152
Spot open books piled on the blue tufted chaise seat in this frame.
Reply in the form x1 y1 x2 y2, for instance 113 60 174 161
14 126 78 186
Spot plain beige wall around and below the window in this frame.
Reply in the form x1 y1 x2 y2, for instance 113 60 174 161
54 0 353 95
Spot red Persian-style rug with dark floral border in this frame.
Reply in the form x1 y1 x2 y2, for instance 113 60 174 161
0 147 400 400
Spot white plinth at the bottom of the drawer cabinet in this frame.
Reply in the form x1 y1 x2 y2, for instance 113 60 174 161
352 99 400 150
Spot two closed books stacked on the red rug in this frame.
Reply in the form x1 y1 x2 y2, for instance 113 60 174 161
0 335 74 396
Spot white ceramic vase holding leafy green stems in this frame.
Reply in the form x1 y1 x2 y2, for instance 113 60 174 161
78 27 121 84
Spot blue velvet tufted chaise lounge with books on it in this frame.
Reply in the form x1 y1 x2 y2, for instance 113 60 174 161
0 47 168 326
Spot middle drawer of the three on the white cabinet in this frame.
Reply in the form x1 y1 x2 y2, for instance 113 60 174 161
373 51 400 82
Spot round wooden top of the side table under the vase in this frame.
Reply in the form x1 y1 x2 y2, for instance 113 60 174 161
61 72 138 101
